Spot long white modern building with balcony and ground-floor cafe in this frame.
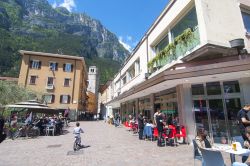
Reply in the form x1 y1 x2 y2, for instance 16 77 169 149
100 0 250 143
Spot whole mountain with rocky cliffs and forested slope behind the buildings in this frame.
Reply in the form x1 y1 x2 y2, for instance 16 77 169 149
0 0 129 82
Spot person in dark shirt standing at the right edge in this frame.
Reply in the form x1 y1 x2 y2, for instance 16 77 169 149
237 104 250 141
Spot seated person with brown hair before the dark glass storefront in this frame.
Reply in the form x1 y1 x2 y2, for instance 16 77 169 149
195 128 212 148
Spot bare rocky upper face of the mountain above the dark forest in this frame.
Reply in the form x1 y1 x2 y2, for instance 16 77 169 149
0 0 128 61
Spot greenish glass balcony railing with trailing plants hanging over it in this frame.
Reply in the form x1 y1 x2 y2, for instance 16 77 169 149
148 27 200 73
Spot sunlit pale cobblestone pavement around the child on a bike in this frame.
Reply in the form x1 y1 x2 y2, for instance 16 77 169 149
0 121 234 166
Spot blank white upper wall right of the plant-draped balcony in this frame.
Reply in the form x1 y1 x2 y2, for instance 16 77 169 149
195 0 247 47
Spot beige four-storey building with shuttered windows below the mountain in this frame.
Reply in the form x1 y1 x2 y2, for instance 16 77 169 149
18 51 87 118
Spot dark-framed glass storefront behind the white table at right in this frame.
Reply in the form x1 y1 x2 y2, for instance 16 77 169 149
192 81 241 144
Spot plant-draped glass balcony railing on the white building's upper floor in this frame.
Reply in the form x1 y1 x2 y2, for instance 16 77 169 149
148 27 200 73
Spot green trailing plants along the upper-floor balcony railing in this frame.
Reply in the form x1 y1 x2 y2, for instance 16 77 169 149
148 28 194 71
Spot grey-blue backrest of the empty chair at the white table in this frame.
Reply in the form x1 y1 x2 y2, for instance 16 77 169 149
200 148 226 166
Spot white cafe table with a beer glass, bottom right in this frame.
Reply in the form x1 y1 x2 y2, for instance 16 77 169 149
212 145 250 163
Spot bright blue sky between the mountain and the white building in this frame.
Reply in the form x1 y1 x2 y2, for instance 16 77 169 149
48 0 169 51
